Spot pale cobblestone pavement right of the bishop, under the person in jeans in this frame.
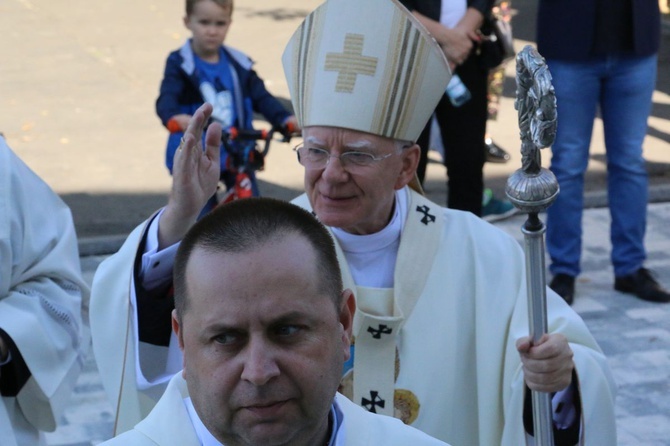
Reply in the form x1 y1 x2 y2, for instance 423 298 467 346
498 203 670 446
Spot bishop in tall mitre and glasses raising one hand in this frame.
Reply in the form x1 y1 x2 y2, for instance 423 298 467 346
94 0 616 446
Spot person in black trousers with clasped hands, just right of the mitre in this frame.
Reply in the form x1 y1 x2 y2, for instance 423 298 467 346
400 0 493 216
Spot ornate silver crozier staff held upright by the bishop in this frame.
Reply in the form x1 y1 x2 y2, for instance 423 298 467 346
505 45 559 446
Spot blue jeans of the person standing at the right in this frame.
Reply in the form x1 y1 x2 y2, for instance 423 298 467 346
547 55 657 276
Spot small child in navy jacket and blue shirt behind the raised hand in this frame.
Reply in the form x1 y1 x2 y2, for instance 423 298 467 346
156 0 298 195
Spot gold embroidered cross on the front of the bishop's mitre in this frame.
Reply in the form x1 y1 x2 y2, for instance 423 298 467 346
324 34 378 93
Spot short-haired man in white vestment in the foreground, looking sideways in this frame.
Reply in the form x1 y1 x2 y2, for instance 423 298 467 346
101 199 452 446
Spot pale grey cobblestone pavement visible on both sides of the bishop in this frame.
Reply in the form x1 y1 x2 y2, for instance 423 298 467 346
47 203 670 446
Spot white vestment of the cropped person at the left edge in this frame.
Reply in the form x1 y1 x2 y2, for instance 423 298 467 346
0 141 89 446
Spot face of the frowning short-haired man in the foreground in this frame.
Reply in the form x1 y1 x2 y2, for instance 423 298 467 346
176 235 353 446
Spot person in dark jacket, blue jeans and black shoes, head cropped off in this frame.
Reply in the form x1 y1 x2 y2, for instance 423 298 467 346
537 0 670 303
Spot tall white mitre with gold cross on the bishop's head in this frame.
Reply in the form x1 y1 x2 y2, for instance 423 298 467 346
282 0 451 141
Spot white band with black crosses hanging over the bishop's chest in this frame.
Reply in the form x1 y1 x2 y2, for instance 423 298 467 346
294 187 444 424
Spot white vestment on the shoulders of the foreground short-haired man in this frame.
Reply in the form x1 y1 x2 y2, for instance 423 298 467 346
102 373 445 446
